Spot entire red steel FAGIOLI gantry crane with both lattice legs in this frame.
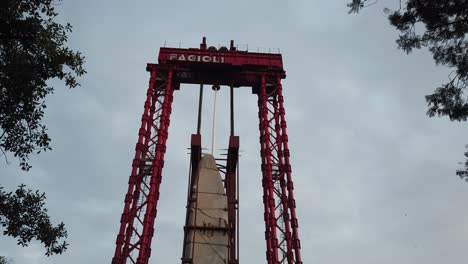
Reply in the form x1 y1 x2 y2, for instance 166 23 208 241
112 37 302 264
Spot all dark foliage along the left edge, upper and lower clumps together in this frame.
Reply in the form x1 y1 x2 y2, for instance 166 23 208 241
0 0 86 258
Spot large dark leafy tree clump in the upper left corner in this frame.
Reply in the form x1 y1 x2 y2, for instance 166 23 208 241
0 0 86 170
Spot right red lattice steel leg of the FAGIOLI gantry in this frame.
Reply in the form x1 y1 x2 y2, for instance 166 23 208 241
258 75 302 264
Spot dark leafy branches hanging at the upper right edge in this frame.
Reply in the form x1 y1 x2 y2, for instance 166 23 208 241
348 0 468 180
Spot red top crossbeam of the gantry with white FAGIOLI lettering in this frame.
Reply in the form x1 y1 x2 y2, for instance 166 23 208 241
147 37 286 88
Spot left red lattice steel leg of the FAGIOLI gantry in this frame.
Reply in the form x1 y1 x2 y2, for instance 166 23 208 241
112 67 173 264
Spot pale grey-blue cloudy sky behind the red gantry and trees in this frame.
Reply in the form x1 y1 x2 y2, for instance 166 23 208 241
0 0 468 264
